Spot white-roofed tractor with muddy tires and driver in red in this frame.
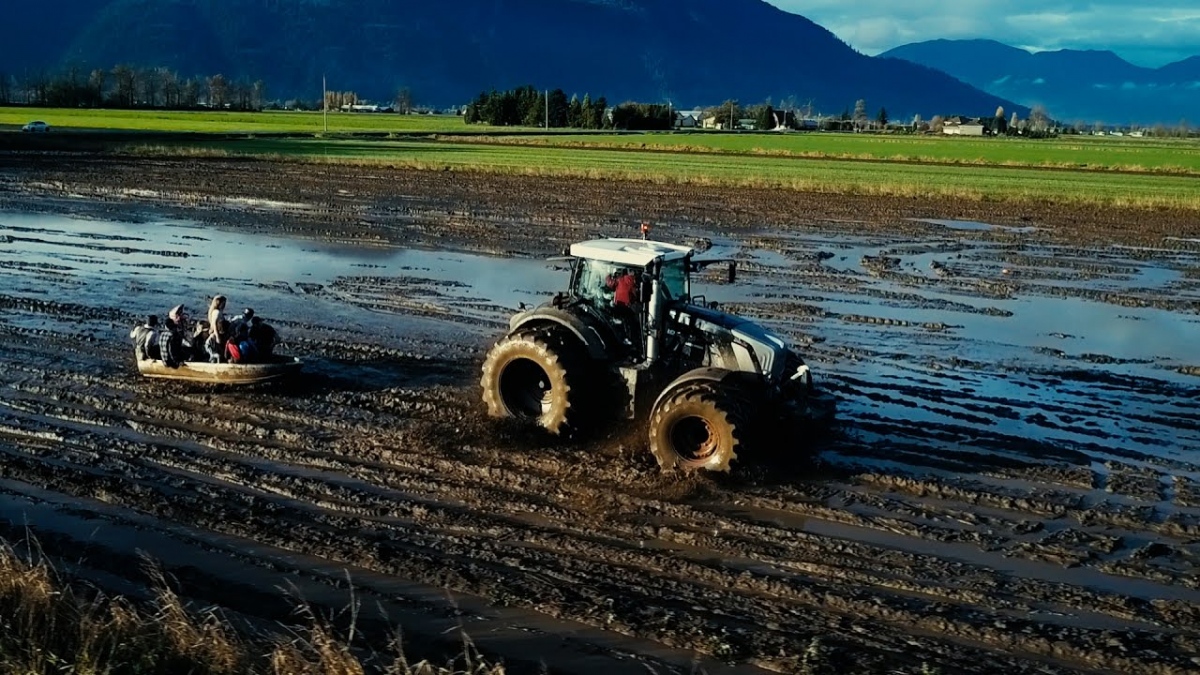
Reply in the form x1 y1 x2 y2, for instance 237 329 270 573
480 226 812 471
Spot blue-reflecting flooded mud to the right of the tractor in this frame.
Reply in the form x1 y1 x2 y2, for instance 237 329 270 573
704 226 1200 471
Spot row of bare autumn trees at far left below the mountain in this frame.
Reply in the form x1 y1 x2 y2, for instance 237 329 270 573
0 64 266 110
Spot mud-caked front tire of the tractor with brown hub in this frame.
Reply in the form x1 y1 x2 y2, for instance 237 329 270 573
650 382 744 471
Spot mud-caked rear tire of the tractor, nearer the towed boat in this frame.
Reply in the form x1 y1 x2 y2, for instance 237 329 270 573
480 330 589 436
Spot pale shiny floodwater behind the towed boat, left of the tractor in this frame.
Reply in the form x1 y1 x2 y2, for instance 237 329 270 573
0 213 564 335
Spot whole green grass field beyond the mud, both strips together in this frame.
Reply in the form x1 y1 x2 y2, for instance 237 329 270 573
7 108 1200 211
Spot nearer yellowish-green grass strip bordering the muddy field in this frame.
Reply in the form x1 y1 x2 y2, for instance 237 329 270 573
131 138 1200 210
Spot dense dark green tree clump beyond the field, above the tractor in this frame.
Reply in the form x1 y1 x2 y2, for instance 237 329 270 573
463 85 608 129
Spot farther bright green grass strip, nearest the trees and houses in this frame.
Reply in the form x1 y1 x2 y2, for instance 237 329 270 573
0 108 1200 174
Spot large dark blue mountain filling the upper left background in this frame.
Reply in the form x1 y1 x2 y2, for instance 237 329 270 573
0 0 1027 119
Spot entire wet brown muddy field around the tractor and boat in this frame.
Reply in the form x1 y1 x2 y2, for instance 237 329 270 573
0 155 1200 674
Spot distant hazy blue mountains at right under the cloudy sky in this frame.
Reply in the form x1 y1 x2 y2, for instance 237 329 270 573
880 40 1200 125
